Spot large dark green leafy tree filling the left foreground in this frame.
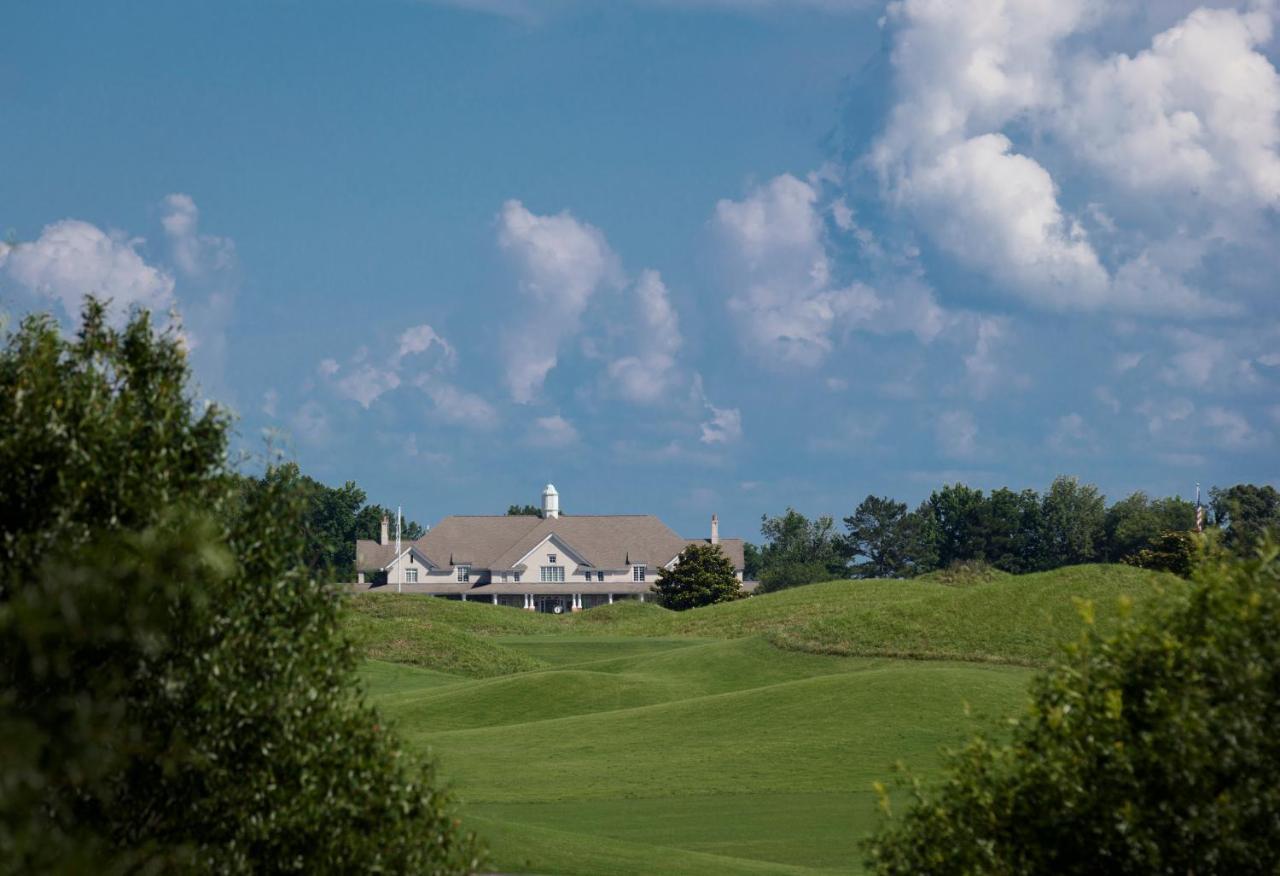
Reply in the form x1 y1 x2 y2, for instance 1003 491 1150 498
0 301 475 873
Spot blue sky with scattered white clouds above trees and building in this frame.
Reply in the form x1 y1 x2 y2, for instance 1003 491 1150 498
0 0 1280 538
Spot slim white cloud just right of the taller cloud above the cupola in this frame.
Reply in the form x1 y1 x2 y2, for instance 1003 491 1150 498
608 270 682 403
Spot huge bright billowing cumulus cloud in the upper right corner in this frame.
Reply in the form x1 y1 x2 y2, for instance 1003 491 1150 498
868 0 1280 315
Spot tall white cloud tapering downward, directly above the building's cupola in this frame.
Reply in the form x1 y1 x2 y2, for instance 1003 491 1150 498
498 200 618 403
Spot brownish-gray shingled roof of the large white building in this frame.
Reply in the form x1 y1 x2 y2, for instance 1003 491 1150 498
356 515 742 572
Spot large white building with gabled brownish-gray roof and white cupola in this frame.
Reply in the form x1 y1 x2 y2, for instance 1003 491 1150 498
356 484 742 612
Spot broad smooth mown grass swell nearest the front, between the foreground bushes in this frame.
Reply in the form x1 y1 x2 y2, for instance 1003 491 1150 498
409 662 1029 803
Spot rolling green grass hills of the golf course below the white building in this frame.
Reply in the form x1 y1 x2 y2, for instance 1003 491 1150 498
348 566 1180 873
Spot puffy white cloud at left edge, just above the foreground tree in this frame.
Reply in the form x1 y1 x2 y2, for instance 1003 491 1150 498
4 219 174 318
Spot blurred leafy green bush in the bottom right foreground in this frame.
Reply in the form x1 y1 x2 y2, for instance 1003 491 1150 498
868 546 1280 875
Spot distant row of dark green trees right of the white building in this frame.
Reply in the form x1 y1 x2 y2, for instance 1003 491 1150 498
745 475 1280 590
